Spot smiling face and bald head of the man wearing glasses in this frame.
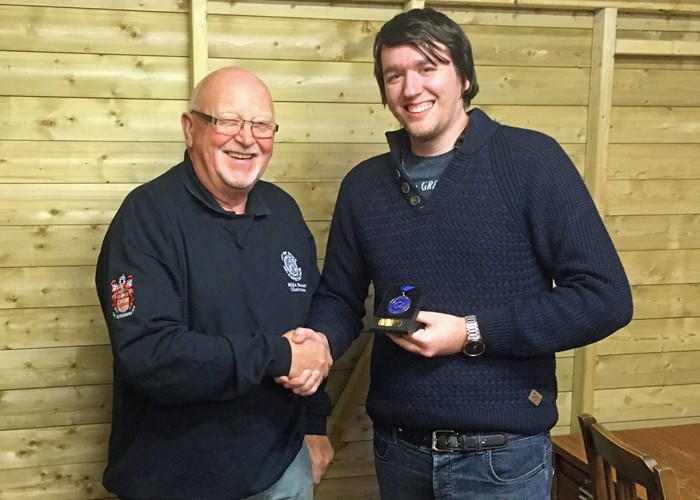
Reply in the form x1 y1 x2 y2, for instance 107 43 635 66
182 68 275 210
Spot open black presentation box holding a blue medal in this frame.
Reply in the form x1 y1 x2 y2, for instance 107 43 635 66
369 286 425 335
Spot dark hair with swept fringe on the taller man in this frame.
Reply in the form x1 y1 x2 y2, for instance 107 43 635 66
374 7 479 107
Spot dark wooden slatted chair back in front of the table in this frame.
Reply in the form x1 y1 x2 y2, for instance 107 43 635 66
578 413 681 500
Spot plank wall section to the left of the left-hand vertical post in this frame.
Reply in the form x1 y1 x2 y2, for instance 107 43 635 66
0 0 189 500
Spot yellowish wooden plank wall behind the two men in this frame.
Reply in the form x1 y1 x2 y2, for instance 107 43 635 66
0 0 700 500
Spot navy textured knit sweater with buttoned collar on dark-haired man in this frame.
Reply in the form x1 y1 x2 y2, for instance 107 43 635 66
308 109 632 434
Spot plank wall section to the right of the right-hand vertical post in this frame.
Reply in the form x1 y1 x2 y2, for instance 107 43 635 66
594 13 700 428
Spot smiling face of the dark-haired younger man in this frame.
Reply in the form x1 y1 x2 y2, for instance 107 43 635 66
381 45 469 156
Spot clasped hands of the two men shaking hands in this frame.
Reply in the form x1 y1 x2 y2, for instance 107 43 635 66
275 328 333 396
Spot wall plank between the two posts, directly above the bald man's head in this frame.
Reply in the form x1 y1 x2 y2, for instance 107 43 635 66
209 15 591 67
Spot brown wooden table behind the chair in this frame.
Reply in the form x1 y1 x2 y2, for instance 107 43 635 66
552 424 700 500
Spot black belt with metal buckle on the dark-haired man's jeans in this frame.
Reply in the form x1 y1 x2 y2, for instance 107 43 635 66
394 427 523 452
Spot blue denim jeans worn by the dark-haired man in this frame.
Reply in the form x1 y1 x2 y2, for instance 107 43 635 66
374 426 553 500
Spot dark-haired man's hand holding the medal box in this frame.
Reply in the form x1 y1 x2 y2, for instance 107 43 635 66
388 311 467 358
